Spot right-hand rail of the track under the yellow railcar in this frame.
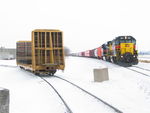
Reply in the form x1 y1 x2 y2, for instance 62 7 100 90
54 75 123 113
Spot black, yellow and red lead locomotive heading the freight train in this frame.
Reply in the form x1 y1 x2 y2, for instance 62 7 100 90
112 36 138 65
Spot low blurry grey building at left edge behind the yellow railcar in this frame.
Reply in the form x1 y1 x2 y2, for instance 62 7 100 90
0 47 16 60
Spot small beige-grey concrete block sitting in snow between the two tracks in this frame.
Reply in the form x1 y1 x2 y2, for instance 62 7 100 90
94 68 109 82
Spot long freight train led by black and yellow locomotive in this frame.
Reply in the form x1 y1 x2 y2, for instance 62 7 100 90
72 36 138 66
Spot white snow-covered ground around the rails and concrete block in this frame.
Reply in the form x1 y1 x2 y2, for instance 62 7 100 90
0 57 150 113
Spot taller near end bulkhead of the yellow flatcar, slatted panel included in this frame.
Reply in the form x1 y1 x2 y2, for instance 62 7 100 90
32 29 65 71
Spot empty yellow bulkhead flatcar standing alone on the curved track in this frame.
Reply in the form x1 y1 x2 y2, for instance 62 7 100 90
16 29 65 75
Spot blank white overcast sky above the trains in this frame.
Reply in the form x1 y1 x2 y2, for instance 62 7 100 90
0 0 150 52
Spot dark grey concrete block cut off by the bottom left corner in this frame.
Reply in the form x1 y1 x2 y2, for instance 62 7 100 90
0 88 9 113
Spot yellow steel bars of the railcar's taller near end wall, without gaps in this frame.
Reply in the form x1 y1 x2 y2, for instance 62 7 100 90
32 29 65 71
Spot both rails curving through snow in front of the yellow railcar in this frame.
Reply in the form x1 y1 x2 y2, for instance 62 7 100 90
40 76 123 113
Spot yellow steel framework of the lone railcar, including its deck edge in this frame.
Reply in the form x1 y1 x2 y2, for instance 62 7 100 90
17 29 65 72
